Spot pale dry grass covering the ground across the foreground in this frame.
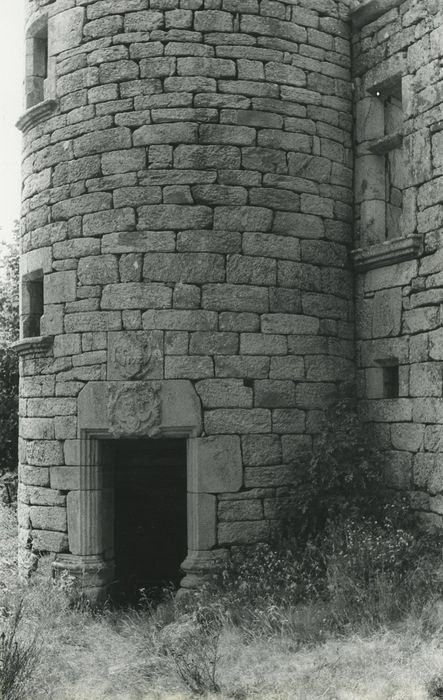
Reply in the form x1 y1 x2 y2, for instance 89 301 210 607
0 510 443 700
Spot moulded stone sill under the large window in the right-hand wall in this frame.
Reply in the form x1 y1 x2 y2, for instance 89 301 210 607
351 234 423 272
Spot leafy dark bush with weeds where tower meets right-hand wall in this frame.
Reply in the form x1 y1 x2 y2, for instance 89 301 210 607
203 399 443 635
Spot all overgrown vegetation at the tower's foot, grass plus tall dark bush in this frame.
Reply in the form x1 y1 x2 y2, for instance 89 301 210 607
0 392 443 700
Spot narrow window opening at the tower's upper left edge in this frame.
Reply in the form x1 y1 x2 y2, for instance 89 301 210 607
26 18 48 109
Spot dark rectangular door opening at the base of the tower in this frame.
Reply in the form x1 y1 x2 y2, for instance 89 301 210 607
110 439 187 603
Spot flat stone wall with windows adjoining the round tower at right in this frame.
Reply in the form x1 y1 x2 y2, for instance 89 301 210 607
353 0 443 525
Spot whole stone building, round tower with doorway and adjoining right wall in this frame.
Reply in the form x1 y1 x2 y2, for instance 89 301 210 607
23 0 443 595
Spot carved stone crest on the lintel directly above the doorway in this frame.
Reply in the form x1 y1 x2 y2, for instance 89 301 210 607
108 382 161 437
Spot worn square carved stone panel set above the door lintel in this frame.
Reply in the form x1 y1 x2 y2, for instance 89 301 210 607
108 331 163 380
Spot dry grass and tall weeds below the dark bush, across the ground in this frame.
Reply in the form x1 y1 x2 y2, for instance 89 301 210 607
0 498 443 700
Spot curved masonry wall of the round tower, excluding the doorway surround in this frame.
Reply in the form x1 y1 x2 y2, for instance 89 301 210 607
19 0 356 584
